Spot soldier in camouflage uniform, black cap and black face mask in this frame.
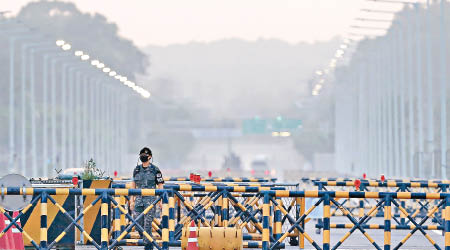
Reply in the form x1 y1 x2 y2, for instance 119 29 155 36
130 147 164 250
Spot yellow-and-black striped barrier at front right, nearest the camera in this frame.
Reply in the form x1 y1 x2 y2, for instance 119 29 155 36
262 191 450 250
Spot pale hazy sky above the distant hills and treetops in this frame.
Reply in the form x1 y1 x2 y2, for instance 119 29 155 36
0 0 404 46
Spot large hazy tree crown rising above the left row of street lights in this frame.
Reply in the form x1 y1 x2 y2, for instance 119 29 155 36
16 1 148 79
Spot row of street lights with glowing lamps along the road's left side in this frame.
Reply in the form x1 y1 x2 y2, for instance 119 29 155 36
0 19 150 177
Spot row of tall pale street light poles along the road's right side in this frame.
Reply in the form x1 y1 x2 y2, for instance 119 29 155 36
336 0 448 179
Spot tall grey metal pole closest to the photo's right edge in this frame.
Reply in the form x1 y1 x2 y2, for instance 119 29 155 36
439 0 447 179
